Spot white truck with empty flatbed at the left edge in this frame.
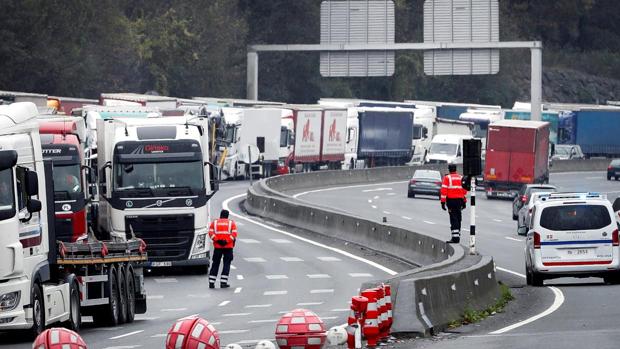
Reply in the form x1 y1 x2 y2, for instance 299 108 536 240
0 102 146 334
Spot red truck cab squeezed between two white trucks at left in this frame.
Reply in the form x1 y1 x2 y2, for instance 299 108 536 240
39 121 87 242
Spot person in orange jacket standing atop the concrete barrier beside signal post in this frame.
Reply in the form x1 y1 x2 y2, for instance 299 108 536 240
441 164 467 244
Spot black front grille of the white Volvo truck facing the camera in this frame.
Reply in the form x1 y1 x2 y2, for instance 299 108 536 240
125 214 194 261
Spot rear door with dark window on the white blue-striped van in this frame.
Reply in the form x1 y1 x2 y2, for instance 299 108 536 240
539 202 618 266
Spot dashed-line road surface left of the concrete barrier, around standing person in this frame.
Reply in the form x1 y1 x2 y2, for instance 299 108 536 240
0 182 404 349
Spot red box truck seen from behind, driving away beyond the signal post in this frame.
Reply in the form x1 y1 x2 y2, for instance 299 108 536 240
484 120 549 197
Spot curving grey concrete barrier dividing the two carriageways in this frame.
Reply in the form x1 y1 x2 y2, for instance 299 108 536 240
245 165 499 335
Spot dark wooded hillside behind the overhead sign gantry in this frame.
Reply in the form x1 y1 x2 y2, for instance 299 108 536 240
0 0 620 107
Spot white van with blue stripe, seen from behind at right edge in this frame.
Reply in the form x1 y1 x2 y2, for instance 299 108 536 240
525 193 620 286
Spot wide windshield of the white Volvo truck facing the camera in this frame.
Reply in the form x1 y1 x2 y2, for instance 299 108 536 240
114 161 205 194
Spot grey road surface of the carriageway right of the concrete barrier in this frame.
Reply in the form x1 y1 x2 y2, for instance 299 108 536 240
291 172 620 348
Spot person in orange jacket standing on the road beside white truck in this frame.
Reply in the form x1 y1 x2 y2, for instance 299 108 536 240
209 210 237 288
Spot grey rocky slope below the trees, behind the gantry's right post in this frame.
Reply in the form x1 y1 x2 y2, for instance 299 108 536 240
517 68 620 104
